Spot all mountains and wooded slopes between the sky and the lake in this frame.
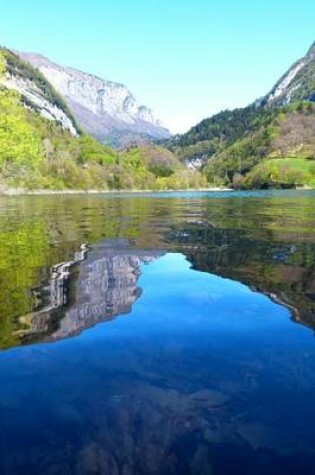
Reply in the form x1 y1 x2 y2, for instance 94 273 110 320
0 44 315 192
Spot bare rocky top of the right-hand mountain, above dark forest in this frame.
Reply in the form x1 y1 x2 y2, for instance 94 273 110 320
262 42 315 106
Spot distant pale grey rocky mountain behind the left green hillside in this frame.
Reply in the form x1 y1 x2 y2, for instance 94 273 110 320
17 52 170 146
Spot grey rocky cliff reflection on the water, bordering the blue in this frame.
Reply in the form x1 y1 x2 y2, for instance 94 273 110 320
19 239 162 343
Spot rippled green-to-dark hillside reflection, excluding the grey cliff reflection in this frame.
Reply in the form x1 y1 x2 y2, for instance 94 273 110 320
0 191 315 348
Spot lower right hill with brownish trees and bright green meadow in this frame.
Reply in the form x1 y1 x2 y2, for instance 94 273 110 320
203 102 315 188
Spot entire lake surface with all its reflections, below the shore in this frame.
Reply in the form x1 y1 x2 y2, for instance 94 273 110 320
0 192 315 475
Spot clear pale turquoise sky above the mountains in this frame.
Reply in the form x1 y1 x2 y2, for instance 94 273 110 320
0 0 315 132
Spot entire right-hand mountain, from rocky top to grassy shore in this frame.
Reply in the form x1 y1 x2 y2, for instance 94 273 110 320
163 43 315 187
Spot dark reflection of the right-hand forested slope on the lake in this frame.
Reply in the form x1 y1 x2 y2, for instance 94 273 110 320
167 223 315 329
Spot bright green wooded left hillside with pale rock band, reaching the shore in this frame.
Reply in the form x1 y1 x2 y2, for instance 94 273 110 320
0 48 206 193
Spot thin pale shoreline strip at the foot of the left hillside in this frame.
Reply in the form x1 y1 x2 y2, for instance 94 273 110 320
0 187 234 196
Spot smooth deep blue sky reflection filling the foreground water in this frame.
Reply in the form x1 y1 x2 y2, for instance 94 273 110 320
0 253 315 475
